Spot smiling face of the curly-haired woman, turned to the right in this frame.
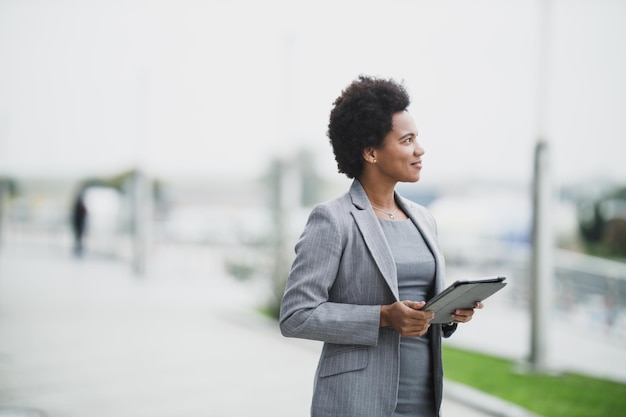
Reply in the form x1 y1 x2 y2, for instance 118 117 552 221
373 111 425 182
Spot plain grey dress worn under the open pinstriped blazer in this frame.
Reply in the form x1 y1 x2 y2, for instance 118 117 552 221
380 219 437 417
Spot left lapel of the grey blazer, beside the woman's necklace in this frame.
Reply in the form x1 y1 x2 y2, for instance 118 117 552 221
350 180 400 300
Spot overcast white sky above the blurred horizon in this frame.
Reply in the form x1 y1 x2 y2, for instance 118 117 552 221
0 0 626 187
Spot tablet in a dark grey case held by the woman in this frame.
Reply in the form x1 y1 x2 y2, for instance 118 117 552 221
422 277 506 323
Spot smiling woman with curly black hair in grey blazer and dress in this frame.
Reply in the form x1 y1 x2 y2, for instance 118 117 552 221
280 76 482 417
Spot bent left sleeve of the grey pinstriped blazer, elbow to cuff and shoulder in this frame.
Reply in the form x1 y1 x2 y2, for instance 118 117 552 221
279 205 380 346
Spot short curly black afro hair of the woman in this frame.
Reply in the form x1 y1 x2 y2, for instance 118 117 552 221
327 75 411 178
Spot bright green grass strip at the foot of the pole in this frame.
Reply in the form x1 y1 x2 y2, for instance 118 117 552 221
443 346 626 417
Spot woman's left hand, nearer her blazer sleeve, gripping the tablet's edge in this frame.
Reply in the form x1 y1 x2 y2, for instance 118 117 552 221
380 301 435 336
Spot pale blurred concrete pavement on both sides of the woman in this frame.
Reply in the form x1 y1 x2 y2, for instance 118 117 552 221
0 240 552 417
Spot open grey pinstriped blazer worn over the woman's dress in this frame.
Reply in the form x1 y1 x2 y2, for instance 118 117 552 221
280 180 456 417
